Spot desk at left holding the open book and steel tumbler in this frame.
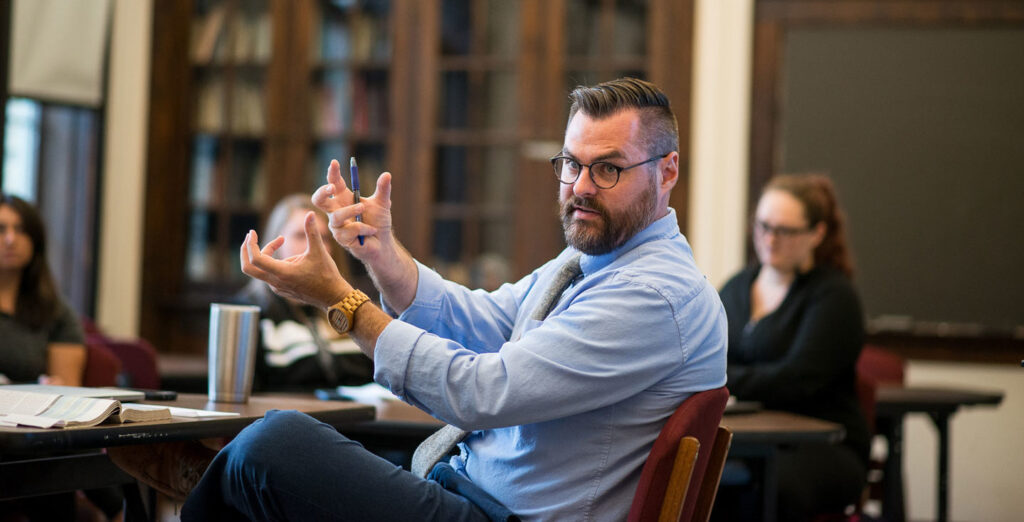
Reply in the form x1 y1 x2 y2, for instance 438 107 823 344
0 394 374 517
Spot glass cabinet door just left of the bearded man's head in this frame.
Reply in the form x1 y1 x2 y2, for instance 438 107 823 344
431 0 523 290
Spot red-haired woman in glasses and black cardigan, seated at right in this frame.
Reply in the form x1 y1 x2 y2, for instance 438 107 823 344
713 175 869 521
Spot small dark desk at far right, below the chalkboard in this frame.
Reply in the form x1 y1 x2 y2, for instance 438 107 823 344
876 385 1002 522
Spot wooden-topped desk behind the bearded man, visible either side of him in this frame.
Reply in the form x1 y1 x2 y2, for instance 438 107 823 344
340 401 845 521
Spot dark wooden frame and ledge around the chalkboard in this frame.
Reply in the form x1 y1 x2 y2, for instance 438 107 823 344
748 0 1024 364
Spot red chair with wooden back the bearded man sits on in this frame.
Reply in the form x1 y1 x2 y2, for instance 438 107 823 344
628 386 731 522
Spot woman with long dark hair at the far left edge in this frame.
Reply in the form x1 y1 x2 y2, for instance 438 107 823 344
0 193 86 386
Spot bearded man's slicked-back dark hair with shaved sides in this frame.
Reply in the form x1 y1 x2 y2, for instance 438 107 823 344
568 78 679 156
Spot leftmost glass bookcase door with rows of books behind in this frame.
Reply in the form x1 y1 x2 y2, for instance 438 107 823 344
184 0 272 285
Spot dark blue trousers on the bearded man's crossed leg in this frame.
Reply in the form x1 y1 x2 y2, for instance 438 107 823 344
181 410 487 522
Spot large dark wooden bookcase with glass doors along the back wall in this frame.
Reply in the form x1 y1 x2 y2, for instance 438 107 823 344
140 0 693 353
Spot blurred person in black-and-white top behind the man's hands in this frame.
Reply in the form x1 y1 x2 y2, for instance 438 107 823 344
232 194 374 391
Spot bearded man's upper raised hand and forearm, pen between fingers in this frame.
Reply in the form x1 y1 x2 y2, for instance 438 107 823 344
312 160 419 312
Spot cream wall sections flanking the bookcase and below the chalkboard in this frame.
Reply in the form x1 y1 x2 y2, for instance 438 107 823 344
97 0 1024 522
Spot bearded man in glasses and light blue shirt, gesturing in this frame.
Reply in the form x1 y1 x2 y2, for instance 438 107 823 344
117 79 726 521
